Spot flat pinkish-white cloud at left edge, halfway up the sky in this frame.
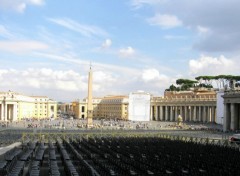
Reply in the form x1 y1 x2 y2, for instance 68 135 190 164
0 40 48 53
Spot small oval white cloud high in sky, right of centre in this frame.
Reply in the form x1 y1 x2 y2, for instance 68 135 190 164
147 14 182 29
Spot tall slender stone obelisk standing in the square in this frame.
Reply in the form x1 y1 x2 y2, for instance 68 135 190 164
87 65 93 127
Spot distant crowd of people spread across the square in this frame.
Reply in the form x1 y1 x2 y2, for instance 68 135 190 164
0 118 222 131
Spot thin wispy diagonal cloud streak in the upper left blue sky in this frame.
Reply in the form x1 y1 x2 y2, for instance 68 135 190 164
48 18 108 37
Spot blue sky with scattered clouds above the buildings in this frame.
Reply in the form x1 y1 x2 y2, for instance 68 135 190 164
0 0 240 102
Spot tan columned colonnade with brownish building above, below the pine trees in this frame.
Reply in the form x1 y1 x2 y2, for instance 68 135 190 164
150 90 216 122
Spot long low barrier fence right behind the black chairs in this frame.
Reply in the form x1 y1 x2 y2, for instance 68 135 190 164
21 131 240 150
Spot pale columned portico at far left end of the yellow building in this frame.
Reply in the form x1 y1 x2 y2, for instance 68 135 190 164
0 102 17 121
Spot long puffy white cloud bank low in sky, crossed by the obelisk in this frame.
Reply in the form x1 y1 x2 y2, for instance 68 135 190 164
0 68 122 101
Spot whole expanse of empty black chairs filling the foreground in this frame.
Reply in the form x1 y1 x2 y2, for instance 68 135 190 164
0 137 240 176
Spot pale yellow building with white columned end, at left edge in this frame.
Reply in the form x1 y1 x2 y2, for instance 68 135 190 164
0 91 57 121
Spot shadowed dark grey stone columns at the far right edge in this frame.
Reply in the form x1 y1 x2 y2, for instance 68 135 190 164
223 103 240 131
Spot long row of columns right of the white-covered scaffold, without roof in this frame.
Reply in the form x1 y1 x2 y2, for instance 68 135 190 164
151 105 216 122
